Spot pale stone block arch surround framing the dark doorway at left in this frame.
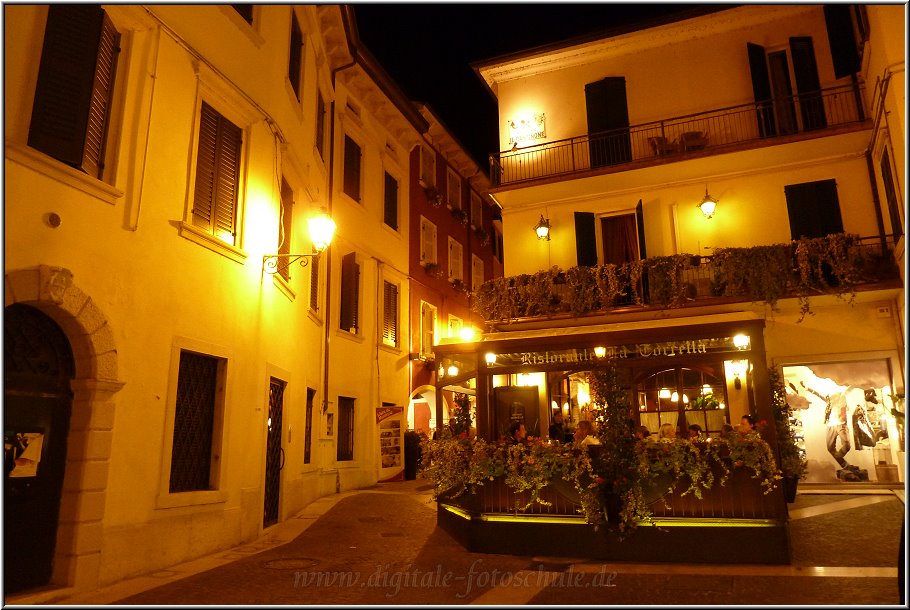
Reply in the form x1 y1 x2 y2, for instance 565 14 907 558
4 265 123 589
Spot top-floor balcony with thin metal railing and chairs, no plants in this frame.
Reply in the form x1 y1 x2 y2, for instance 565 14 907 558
490 85 866 188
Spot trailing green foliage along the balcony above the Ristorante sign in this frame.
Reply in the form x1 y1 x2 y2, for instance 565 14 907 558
473 233 896 322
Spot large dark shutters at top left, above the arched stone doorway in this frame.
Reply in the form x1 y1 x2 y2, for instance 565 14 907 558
28 4 120 178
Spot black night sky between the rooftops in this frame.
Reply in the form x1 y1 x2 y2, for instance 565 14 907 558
354 3 718 171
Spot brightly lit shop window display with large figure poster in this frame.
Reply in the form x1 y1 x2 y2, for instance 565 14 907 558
783 360 904 484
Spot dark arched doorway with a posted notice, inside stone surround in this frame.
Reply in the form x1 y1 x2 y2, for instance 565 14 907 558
3 304 75 593
